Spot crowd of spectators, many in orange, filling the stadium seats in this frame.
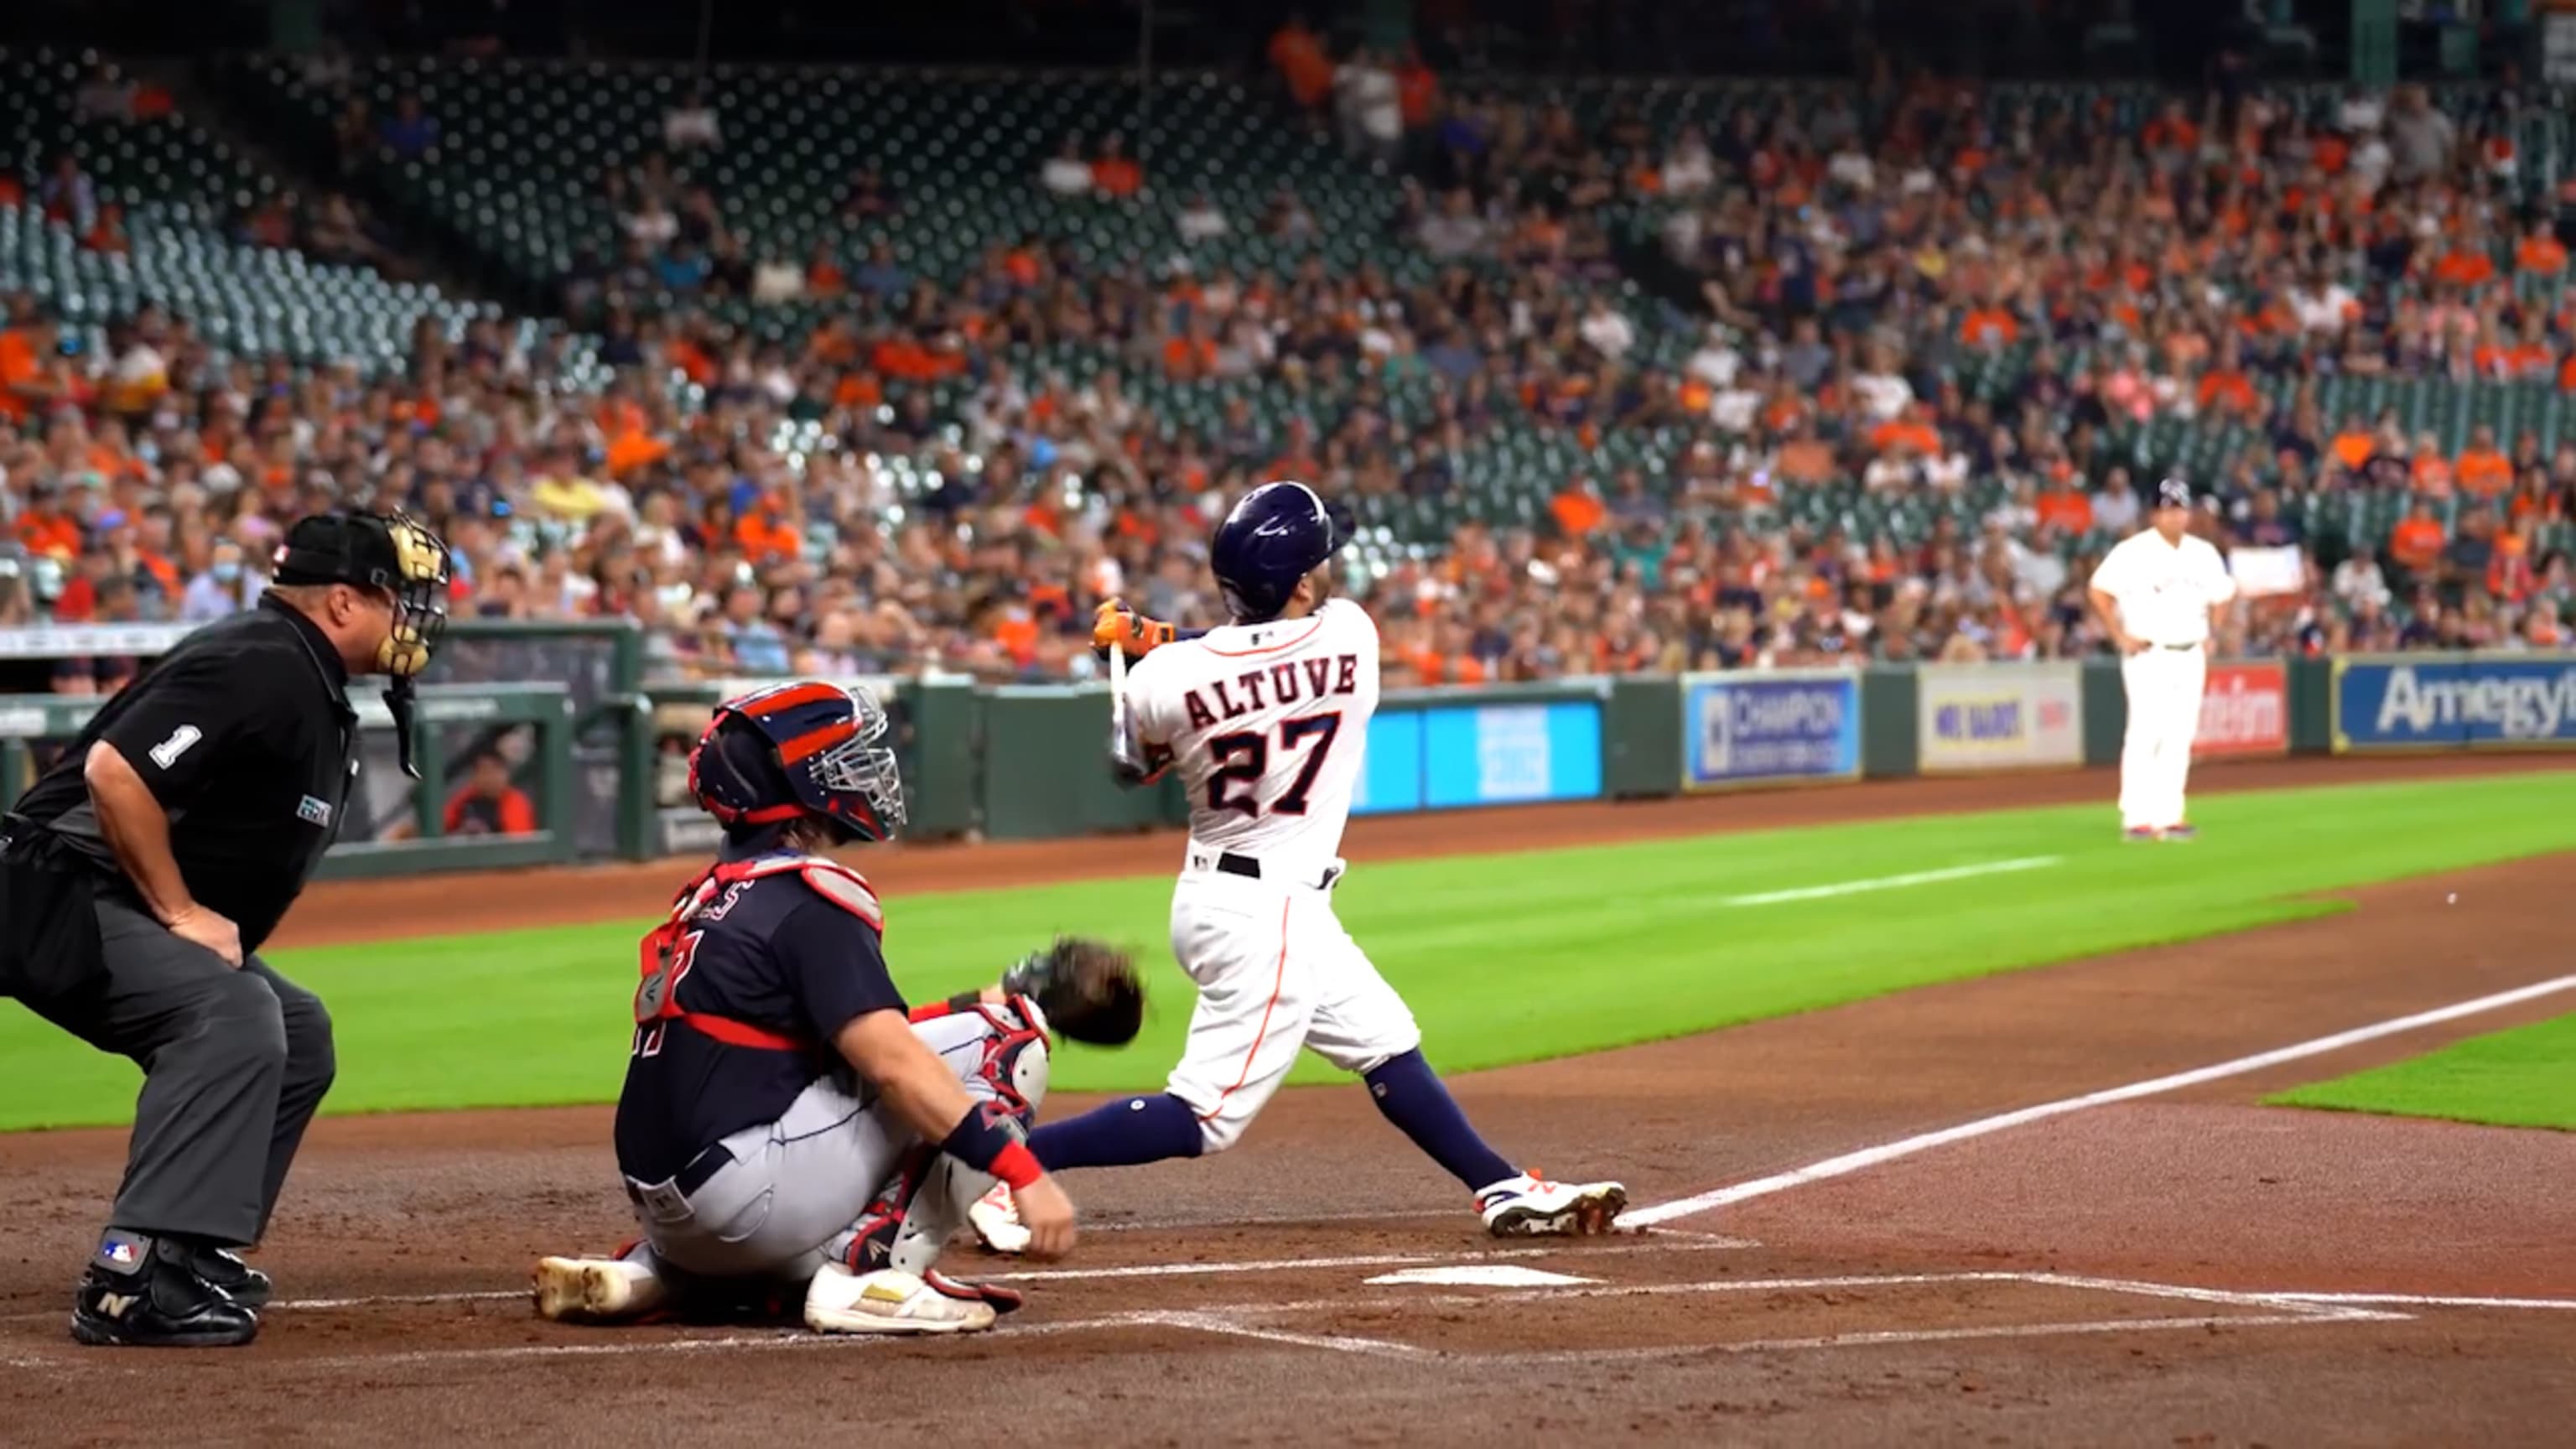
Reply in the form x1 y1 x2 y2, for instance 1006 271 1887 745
0 40 2576 688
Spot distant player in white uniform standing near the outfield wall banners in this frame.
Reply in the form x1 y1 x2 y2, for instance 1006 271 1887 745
2091 477 2236 840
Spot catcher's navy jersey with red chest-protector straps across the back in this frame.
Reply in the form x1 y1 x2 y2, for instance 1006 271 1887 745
615 856 904 1183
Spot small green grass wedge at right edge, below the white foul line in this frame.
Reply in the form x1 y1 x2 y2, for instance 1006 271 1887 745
2269 1015 2576 1132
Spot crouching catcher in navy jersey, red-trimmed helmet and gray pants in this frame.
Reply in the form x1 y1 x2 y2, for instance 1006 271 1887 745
536 681 1144 1333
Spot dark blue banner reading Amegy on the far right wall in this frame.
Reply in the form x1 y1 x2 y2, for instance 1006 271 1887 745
2334 655 2576 753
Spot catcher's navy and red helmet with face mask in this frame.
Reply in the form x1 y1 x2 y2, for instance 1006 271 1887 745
688 678 904 840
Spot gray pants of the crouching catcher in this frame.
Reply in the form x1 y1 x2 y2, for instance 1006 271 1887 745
626 1008 1046 1281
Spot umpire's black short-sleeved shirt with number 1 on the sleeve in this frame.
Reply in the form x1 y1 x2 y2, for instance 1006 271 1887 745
18 595 358 954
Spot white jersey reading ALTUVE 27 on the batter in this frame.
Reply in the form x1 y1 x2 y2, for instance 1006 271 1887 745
1129 598 1379 879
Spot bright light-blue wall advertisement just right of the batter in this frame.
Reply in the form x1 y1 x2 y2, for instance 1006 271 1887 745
1350 699 1602 815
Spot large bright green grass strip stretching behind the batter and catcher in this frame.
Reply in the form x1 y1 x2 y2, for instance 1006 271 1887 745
0 773 2576 1130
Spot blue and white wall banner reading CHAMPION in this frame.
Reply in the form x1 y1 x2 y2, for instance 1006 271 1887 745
1682 670 1860 789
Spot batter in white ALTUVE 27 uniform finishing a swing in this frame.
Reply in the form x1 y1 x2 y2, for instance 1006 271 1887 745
971 482 1628 1250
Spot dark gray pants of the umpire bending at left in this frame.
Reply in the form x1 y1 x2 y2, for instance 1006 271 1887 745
57 895 337 1245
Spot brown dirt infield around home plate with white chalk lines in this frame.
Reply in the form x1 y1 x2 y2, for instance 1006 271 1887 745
0 761 2576 1446
